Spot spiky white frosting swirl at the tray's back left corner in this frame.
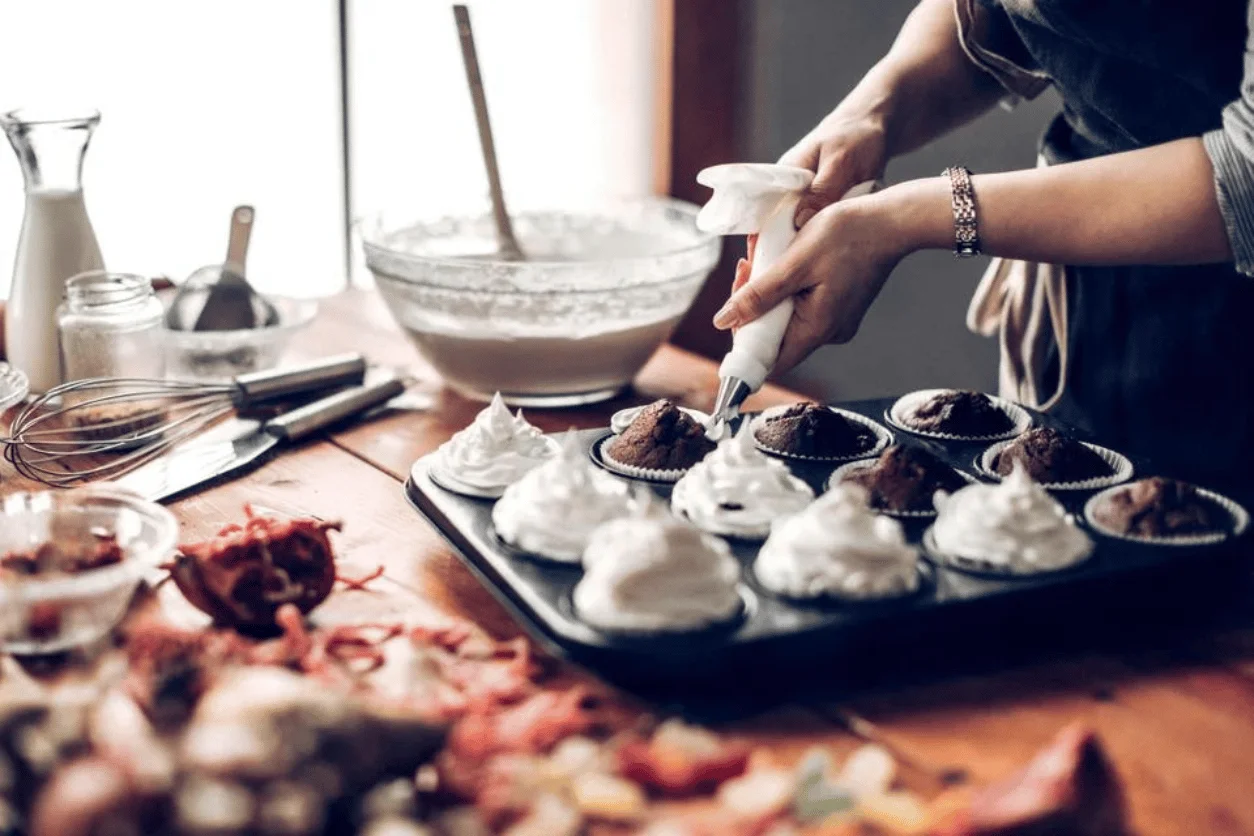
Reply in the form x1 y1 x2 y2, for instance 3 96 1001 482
439 392 557 490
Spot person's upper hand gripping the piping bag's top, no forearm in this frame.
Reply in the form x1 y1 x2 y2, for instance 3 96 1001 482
780 109 888 228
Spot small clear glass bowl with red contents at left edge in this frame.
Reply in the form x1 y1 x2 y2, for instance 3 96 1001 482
0 485 178 656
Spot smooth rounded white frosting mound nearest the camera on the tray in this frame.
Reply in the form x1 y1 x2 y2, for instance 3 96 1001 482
574 499 741 632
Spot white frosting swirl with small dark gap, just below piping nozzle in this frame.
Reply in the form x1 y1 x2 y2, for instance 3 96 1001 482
671 421 814 539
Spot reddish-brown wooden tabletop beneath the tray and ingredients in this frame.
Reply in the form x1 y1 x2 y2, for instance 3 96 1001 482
4 291 1254 833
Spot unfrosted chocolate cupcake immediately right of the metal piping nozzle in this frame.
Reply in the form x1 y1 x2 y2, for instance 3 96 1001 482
754 402 879 460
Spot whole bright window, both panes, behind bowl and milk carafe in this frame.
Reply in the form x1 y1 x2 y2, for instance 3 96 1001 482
0 0 653 296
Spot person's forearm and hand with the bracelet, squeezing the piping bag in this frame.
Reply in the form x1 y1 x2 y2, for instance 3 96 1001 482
715 138 1233 371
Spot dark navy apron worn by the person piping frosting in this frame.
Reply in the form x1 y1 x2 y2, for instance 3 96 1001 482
983 0 1254 493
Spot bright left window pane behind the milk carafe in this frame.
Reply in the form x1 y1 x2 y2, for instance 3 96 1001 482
0 0 345 296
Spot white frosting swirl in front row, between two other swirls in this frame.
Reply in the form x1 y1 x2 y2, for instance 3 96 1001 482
754 485 919 598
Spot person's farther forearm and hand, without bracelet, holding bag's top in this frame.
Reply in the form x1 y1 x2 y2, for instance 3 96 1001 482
780 0 1006 226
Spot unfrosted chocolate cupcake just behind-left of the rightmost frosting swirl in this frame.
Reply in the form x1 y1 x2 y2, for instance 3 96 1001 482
838 444 967 515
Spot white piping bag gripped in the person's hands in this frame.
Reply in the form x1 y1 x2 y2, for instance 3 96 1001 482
719 180 878 392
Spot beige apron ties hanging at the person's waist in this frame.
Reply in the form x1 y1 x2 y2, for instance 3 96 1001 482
967 160 1067 410
